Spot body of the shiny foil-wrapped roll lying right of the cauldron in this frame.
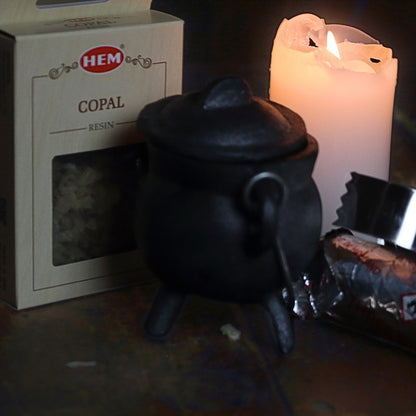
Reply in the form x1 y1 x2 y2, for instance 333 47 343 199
323 231 416 352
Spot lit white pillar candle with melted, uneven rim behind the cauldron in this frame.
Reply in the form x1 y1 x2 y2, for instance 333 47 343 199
270 14 397 233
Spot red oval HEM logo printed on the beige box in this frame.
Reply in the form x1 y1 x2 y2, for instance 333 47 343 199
79 45 124 74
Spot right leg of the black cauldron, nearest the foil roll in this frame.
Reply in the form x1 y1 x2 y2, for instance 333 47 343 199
262 293 295 355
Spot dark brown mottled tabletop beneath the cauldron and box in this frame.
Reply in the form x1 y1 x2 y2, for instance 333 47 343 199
0 274 416 416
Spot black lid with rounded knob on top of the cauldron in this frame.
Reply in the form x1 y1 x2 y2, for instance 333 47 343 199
138 77 307 161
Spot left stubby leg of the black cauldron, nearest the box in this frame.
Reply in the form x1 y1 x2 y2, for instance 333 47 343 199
143 285 188 339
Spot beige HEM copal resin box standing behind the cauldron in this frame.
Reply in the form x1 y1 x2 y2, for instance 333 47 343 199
0 0 183 309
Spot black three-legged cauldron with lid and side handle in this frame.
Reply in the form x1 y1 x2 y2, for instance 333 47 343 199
138 77 321 353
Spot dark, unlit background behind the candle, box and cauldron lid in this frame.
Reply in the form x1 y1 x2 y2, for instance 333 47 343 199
152 0 416 185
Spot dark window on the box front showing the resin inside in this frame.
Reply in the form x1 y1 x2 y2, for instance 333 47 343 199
52 145 144 266
